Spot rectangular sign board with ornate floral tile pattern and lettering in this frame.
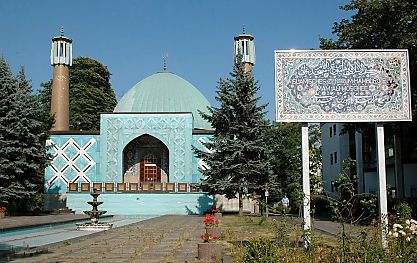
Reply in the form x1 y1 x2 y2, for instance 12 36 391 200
275 50 411 122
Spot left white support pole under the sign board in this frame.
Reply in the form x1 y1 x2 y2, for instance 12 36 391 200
301 123 311 248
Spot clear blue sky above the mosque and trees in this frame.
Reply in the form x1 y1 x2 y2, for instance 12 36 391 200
0 0 351 120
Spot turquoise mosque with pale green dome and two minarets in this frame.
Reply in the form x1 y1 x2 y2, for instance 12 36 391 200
45 29 255 215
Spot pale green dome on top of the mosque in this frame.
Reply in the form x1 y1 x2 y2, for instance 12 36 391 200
114 71 212 129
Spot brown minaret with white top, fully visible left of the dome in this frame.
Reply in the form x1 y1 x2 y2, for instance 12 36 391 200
51 29 72 131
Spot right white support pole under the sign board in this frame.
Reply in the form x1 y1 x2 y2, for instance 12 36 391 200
376 123 388 248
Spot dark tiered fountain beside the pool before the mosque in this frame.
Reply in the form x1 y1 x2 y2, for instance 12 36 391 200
76 189 113 230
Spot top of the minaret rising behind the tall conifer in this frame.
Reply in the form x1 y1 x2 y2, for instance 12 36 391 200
234 27 256 73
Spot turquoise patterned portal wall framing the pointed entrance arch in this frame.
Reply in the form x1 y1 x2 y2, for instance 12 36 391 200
100 113 193 182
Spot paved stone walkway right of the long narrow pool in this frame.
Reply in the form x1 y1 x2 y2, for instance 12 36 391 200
2 215 203 263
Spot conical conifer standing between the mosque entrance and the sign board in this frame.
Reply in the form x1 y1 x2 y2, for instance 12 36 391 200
195 59 272 215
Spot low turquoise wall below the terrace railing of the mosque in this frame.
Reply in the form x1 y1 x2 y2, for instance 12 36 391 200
66 193 213 215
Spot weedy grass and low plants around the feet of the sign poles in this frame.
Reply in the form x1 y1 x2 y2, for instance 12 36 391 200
231 218 417 263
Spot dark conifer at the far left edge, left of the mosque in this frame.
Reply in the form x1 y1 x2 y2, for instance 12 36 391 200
0 59 51 211
